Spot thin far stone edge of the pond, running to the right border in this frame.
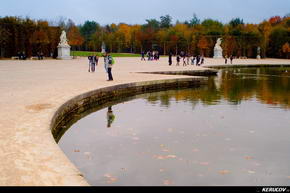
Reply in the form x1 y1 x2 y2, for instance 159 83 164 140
205 64 290 69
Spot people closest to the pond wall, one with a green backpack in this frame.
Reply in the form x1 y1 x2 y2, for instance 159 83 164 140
88 53 115 81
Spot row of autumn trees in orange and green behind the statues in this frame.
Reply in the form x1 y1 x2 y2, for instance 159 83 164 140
0 14 290 58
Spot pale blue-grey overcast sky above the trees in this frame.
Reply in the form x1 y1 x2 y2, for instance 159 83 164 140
0 0 290 25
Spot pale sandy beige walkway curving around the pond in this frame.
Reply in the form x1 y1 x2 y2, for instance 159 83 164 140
0 58 290 186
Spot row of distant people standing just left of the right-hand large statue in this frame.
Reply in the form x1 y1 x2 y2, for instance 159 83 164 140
168 51 204 66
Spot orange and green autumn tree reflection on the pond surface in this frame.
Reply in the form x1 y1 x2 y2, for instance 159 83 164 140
148 68 290 108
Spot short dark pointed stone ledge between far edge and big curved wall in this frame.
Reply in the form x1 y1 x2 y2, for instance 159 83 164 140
137 69 218 76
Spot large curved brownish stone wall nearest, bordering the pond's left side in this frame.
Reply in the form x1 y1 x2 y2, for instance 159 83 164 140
50 77 207 142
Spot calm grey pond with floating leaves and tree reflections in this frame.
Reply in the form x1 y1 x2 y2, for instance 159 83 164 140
58 68 290 186
